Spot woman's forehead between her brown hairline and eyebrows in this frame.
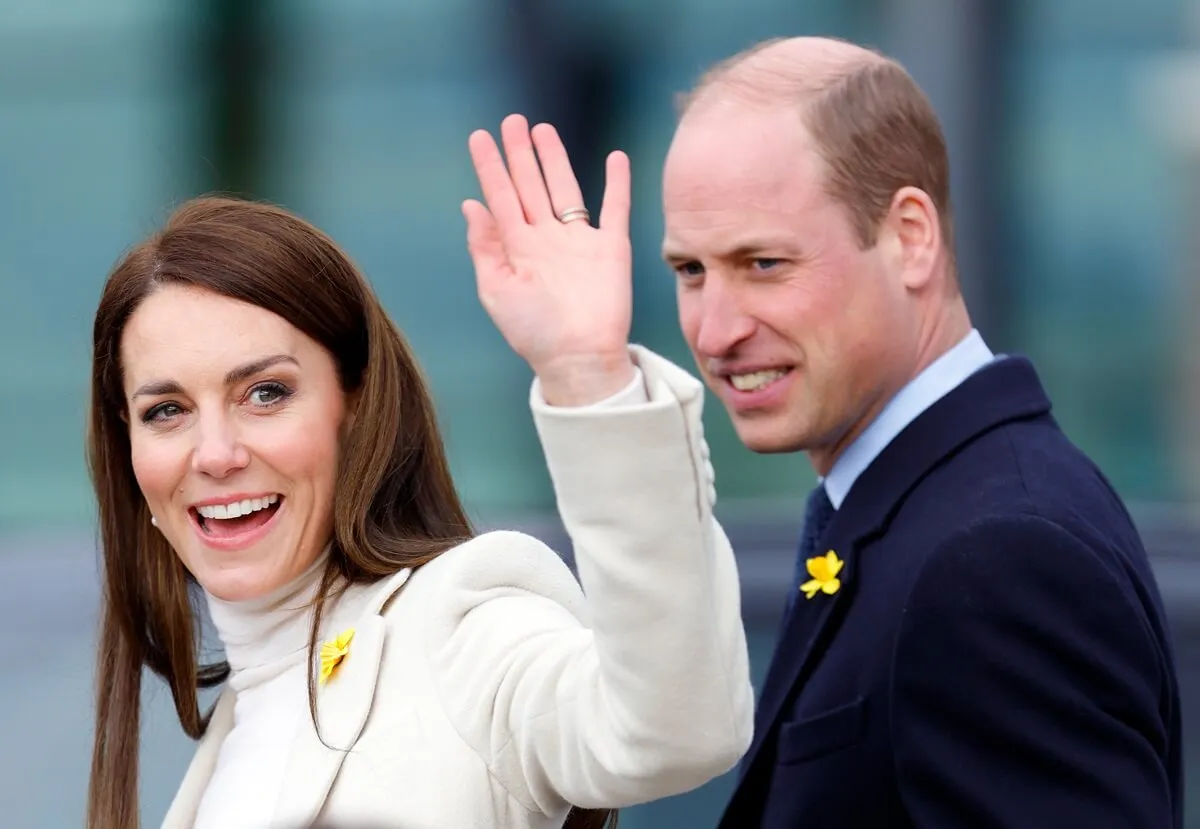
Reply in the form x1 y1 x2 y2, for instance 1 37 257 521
121 286 307 384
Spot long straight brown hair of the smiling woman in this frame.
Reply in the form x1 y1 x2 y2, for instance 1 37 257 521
88 197 616 829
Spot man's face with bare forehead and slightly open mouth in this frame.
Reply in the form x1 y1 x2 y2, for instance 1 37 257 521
664 102 916 473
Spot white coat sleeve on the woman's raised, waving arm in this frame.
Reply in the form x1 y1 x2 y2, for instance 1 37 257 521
425 350 754 813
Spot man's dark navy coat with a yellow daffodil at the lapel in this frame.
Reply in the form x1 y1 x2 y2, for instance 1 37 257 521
720 358 1183 829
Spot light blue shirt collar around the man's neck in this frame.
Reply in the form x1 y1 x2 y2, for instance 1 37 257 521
822 329 996 510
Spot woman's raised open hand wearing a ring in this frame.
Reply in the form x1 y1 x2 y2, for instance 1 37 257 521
462 115 634 406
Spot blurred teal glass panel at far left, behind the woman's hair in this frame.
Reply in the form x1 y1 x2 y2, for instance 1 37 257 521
0 0 191 531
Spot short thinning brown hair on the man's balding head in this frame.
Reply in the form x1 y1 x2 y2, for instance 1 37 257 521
678 37 954 259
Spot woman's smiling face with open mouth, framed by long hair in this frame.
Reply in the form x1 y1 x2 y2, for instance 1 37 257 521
121 286 347 601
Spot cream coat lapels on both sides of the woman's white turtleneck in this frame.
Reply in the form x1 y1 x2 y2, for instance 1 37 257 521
163 570 412 829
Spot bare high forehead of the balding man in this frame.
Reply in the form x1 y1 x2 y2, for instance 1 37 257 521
662 103 834 246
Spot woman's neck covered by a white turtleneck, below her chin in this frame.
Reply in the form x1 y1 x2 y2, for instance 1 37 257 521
204 547 329 689
